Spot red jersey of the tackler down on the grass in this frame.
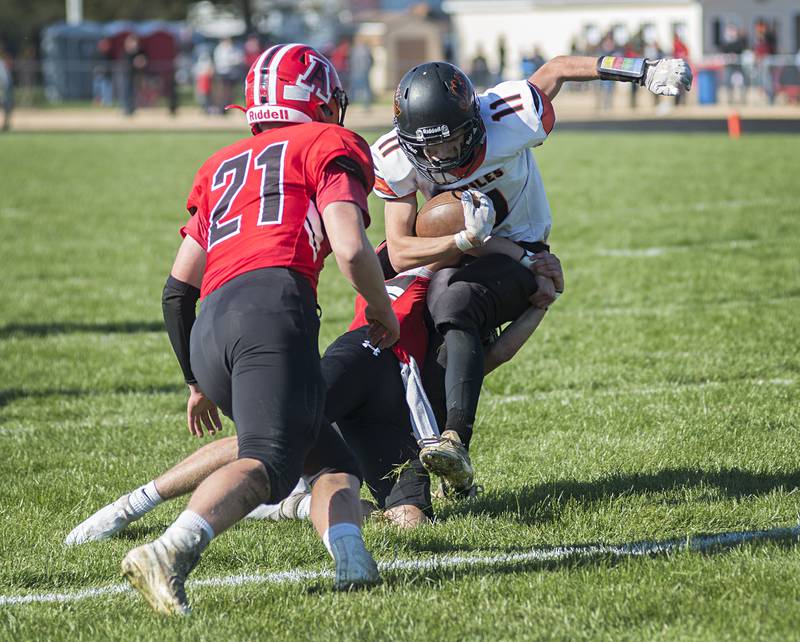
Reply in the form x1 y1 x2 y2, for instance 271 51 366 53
348 268 432 364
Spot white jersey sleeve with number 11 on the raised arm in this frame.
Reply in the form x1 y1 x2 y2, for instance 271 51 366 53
480 80 556 149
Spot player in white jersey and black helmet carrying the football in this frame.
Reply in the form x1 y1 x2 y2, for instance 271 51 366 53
372 56 692 492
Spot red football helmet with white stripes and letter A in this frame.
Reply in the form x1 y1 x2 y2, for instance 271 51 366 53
229 43 347 134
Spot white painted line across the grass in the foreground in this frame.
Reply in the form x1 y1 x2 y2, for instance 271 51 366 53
0 525 800 606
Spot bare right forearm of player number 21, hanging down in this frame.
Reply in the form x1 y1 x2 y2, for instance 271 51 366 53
322 201 400 348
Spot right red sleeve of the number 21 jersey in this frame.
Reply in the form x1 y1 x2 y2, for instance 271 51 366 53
305 125 375 193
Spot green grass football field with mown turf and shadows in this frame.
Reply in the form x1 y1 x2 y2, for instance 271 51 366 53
0 127 800 641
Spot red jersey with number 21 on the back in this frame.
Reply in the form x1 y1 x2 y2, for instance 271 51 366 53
181 122 374 297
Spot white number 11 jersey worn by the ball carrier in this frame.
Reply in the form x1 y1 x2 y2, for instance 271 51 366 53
372 80 555 242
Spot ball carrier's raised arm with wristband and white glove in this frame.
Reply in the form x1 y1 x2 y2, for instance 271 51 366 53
528 56 692 100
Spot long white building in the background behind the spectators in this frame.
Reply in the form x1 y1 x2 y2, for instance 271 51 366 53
442 0 800 77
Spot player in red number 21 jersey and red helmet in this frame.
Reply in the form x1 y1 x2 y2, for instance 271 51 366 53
122 44 399 614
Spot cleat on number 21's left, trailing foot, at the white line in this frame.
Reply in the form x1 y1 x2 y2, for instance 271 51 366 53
122 539 200 615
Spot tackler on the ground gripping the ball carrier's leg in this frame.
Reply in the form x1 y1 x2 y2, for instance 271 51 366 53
64 245 560 545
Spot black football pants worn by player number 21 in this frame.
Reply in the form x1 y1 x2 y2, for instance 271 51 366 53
191 268 361 504
